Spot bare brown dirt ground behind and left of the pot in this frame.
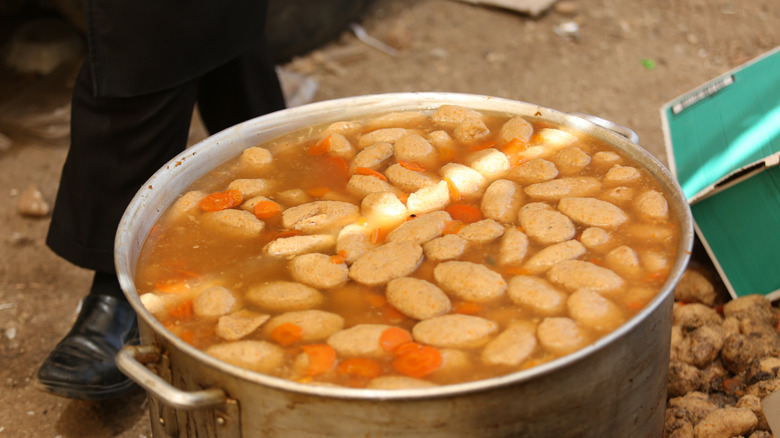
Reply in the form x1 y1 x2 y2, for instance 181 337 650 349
0 0 780 438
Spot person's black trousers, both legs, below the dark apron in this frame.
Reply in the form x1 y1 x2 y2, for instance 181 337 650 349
46 42 284 273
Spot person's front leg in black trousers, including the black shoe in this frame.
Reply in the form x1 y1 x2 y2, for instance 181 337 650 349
36 60 200 400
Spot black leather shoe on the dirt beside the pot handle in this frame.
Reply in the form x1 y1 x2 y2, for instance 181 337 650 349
36 294 138 400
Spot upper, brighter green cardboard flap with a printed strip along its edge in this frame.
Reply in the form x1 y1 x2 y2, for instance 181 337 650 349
661 47 780 199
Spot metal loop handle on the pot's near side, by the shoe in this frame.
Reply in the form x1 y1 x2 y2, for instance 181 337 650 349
116 345 228 410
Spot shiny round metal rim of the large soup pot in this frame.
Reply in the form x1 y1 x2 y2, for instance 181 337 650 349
114 92 693 400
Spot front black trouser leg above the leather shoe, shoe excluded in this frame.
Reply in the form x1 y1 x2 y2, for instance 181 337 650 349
46 64 197 273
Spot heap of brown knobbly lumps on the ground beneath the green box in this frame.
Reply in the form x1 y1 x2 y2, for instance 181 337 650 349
664 268 780 438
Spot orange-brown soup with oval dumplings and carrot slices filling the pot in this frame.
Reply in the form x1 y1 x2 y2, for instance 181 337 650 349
135 105 678 389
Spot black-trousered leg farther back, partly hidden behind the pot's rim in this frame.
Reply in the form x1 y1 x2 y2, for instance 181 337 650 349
198 36 285 134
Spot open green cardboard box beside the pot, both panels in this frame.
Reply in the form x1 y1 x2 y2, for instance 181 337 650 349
661 47 780 300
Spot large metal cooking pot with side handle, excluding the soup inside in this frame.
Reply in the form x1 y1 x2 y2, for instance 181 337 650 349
116 93 693 438
